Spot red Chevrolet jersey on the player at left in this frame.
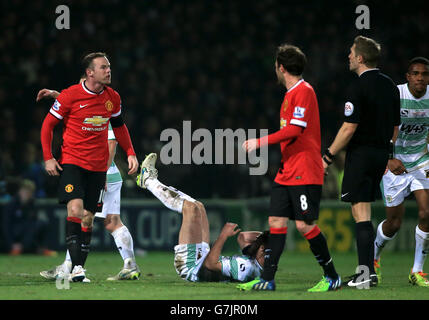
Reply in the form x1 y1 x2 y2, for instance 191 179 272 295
49 82 121 171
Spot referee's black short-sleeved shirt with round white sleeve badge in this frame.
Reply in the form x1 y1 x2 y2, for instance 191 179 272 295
344 69 401 148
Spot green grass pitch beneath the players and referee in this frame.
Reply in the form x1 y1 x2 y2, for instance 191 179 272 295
0 251 429 300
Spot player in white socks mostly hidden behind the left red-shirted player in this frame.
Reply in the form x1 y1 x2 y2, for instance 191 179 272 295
36 89 141 282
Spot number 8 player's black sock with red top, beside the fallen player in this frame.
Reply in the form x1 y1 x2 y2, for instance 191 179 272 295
261 227 287 281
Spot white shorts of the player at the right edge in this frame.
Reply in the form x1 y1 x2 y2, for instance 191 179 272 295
380 167 429 207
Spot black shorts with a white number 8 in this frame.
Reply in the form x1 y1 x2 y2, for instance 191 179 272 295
269 182 322 222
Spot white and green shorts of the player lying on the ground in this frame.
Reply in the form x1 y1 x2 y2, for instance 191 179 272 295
174 242 210 282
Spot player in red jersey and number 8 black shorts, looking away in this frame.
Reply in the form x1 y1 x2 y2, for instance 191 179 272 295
238 44 341 292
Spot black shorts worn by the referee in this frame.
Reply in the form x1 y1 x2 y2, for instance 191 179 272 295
341 146 389 203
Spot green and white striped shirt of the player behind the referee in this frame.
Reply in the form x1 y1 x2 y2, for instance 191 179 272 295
395 83 429 171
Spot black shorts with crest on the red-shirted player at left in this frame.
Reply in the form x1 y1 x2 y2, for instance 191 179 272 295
58 164 106 214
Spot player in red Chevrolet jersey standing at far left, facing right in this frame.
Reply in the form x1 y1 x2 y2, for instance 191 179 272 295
41 52 138 282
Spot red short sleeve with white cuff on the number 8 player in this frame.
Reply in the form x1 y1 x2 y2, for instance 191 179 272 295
289 88 317 128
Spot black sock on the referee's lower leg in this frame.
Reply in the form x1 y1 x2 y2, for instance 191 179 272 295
356 221 375 274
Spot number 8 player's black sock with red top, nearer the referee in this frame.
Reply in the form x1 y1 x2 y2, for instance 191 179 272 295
304 225 338 279
